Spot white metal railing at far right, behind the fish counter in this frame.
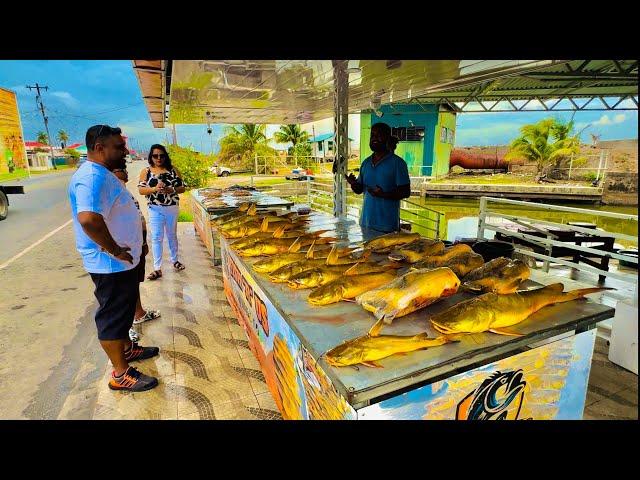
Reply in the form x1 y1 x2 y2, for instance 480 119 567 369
477 197 638 283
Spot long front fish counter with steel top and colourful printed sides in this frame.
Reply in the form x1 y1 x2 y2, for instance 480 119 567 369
214 212 614 420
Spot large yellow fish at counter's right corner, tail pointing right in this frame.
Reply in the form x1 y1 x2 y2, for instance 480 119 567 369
430 283 611 336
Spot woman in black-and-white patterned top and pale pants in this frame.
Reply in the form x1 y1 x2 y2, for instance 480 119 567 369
138 144 185 280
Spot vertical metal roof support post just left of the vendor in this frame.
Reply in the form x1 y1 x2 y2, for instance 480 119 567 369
332 60 349 217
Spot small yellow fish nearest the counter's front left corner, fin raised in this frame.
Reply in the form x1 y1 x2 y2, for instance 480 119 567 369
325 320 457 368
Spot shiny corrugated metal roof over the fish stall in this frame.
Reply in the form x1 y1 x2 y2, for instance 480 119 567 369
133 60 638 127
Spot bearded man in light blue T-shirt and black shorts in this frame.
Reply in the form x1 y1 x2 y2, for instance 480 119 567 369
69 125 159 392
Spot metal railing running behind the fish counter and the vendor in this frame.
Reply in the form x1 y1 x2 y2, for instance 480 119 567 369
258 180 444 239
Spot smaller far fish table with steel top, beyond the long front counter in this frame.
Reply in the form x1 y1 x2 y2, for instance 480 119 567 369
190 188 293 265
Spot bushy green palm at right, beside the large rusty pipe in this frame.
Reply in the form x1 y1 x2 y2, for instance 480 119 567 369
505 118 582 178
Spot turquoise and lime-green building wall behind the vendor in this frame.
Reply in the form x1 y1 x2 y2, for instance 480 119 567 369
360 104 442 176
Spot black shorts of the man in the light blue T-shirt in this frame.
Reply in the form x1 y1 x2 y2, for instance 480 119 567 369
90 267 140 340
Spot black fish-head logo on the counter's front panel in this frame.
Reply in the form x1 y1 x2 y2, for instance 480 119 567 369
456 370 531 420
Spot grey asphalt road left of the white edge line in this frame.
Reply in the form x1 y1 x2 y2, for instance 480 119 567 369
0 169 75 265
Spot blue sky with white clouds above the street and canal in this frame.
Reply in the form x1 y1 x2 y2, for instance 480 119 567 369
0 60 638 152
